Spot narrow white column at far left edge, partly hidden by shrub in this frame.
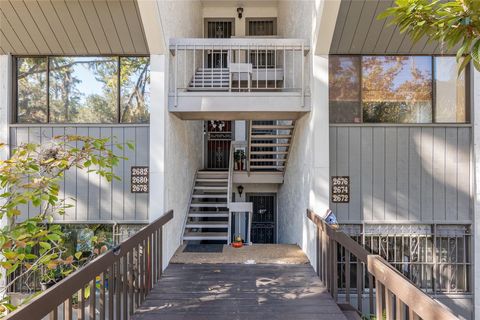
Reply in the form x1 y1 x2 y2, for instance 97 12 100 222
0 55 12 298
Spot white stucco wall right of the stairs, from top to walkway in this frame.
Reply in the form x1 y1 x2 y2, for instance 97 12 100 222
278 1 338 267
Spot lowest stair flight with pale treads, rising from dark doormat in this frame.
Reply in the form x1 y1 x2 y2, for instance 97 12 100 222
183 171 229 243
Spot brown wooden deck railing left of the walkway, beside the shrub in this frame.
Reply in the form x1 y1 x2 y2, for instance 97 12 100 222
5 211 173 320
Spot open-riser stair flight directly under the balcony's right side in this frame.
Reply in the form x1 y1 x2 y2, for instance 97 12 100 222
249 120 295 172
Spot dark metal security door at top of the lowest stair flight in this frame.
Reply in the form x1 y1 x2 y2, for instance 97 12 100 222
205 120 233 170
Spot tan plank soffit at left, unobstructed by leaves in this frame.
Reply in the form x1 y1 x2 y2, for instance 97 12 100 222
0 0 149 55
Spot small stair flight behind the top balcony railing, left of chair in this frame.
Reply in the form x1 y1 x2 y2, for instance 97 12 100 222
188 68 230 91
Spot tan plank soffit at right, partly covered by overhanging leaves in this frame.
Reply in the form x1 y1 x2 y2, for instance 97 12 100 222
330 0 455 54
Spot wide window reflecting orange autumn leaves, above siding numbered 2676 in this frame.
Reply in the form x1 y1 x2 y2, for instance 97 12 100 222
329 56 468 123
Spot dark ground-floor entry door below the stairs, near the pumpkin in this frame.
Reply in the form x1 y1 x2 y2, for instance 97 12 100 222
247 193 277 243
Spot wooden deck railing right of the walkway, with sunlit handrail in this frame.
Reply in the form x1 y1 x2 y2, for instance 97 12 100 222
307 210 458 320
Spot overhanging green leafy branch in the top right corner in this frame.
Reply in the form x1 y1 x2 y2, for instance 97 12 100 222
378 0 480 74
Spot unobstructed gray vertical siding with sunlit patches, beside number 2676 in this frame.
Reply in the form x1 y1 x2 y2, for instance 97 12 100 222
330 126 473 223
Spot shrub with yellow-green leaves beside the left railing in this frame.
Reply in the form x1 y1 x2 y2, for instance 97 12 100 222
0 135 123 314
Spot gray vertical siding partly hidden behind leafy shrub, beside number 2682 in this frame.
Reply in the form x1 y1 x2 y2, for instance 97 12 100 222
10 125 149 223
